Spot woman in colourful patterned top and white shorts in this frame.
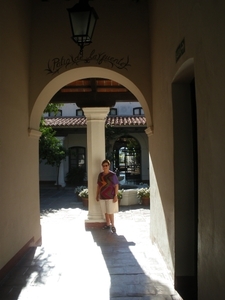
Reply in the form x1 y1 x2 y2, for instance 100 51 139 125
96 159 119 233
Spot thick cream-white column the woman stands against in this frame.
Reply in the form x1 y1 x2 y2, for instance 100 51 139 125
83 107 109 226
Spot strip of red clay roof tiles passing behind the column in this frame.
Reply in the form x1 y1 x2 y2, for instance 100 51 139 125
45 116 147 127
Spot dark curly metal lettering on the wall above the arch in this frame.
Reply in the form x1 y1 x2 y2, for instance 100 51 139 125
45 50 131 75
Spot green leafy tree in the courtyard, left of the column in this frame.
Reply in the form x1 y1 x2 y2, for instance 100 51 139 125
39 103 67 185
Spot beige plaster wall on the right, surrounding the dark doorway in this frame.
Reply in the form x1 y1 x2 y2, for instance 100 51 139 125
150 0 225 299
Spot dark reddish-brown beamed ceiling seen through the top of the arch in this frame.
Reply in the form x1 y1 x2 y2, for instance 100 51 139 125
51 78 137 108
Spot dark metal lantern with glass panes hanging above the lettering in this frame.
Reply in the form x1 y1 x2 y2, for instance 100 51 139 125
67 0 98 56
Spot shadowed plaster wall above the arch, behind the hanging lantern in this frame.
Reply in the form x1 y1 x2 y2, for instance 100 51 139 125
29 0 151 125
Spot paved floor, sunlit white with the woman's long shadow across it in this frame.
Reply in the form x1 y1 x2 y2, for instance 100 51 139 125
0 188 182 300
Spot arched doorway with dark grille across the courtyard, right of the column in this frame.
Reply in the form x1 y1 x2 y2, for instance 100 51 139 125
113 135 141 184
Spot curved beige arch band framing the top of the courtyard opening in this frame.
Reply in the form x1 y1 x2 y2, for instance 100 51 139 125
29 67 152 130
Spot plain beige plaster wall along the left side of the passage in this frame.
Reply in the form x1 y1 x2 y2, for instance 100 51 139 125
0 1 40 269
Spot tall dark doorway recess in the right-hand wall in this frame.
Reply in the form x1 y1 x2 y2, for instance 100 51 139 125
172 59 198 299
